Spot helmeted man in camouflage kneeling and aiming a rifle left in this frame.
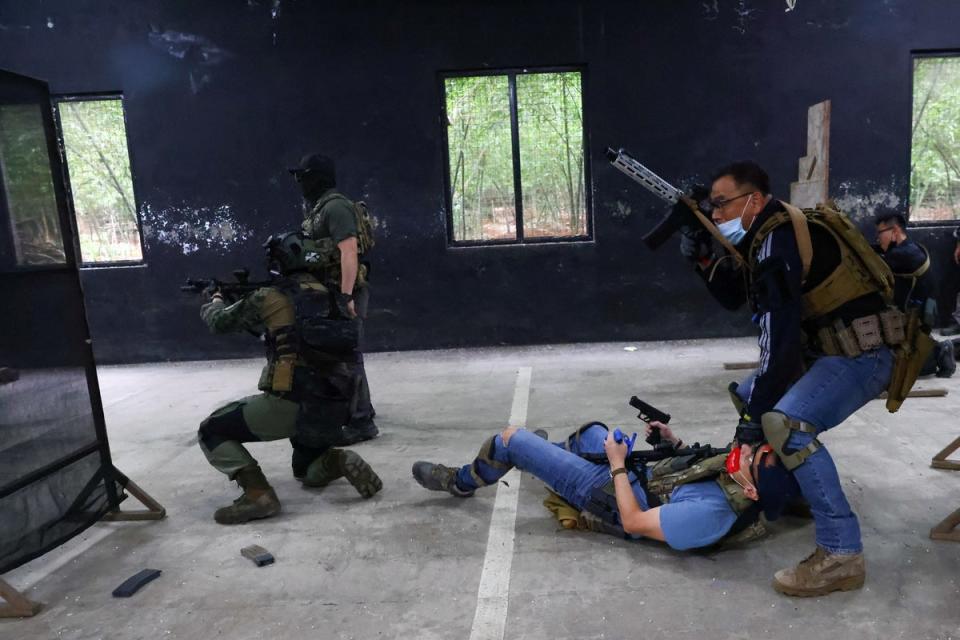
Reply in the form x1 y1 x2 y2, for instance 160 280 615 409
199 232 382 524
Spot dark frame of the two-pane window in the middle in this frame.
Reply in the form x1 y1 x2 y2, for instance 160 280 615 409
437 64 594 248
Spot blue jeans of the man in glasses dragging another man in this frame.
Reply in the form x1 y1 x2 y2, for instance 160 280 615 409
737 347 893 554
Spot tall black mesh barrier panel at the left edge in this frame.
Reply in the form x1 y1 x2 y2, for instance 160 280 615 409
0 71 122 574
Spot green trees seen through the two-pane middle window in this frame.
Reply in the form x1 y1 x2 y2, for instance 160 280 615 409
444 71 588 243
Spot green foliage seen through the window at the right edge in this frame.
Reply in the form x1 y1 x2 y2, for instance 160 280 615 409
910 56 960 220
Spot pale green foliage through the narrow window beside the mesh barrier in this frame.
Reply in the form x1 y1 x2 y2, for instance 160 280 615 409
59 98 143 262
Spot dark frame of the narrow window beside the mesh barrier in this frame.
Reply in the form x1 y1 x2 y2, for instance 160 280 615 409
50 91 147 270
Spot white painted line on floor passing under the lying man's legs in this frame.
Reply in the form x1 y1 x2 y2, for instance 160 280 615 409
470 367 533 640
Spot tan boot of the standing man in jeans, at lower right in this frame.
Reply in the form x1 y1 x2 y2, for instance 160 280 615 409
773 547 867 598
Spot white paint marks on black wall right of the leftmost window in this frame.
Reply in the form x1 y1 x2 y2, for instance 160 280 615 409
140 204 254 255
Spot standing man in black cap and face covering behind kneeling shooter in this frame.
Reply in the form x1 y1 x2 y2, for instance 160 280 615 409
290 153 379 444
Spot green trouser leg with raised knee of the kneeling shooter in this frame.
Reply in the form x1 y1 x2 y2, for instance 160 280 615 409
199 393 300 479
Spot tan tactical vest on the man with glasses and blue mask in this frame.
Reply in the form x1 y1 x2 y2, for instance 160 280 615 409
747 202 893 321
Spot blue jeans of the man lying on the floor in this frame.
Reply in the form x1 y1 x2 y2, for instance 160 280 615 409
457 425 647 510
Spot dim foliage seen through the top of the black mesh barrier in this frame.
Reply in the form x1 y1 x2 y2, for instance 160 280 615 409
0 104 65 265
